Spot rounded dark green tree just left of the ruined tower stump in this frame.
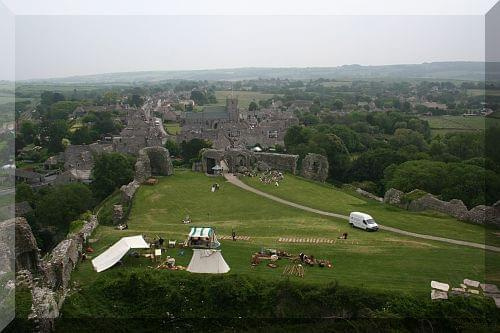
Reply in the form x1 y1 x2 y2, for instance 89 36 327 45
91 153 135 200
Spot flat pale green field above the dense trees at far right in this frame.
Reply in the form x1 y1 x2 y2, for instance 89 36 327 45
422 116 485 135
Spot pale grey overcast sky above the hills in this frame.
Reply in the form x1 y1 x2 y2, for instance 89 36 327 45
0 0 492 79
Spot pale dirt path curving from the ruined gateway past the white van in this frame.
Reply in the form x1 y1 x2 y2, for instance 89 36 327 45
224 173 500 252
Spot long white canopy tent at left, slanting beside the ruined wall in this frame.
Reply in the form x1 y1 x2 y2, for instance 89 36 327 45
92 235 149 273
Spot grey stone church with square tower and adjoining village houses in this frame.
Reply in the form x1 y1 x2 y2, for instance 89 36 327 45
177 97 298 149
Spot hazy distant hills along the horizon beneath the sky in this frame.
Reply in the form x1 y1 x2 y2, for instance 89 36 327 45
23 61 492 84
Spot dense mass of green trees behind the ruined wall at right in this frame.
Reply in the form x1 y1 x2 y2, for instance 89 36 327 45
285 111 492 207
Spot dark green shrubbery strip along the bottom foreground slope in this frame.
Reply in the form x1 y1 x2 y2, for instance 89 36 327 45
58 269 500 331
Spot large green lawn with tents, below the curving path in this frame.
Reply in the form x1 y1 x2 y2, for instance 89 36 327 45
68 170 499 297
